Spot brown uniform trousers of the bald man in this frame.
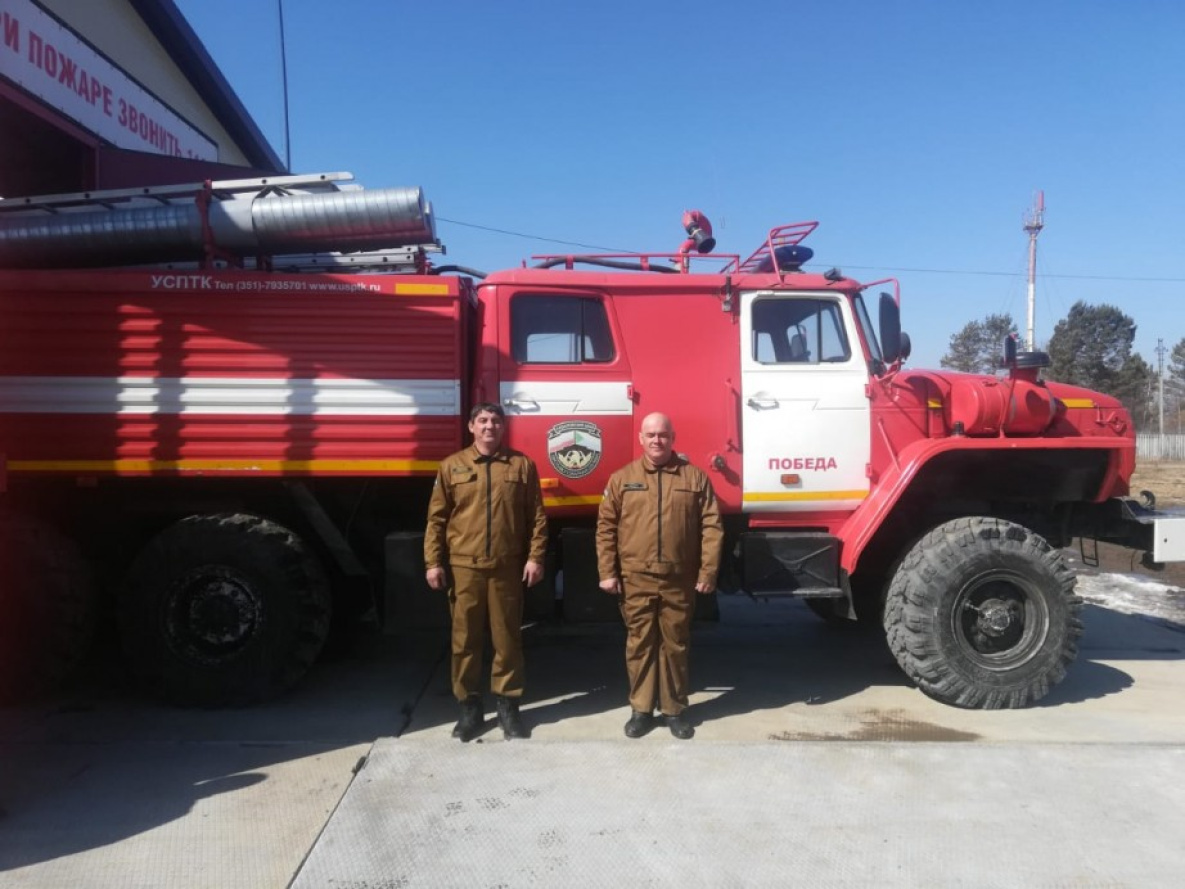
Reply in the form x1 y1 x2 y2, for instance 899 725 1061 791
621 573 696 716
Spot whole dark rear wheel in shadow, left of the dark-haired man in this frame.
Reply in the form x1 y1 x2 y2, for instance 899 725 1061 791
120 514 331 706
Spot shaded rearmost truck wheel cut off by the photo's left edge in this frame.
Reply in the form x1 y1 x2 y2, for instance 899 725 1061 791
0 511 97 702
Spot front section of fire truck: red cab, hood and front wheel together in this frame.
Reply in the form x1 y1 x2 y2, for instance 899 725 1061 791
475 212 1185 708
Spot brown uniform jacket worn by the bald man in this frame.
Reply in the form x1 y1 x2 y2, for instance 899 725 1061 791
596 454 724 586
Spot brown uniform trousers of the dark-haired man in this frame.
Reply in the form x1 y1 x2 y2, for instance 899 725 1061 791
449 565 524 701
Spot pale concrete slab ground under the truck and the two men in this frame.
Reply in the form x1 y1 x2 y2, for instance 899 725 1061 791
0 585 1185 889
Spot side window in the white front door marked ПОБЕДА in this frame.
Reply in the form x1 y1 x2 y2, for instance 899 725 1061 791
752 296 851 364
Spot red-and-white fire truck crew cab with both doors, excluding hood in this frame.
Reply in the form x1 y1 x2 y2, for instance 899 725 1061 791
476 225 883 530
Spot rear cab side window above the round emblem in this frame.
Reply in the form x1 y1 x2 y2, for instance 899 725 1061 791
511 294 616 364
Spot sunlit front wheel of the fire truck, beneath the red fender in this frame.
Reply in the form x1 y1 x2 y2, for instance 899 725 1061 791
884 517 1082 710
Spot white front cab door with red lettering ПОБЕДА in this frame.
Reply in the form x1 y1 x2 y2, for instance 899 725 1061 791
741 292 871 513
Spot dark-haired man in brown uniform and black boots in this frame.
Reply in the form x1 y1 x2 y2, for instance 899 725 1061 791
424 403 547 741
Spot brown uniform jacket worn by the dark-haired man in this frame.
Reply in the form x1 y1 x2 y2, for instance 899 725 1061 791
424 446 547 570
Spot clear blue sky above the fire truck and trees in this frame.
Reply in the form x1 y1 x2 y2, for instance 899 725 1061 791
175 0 1185 367
